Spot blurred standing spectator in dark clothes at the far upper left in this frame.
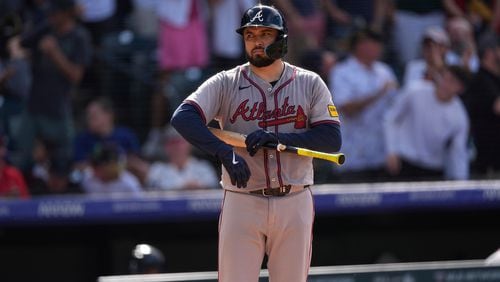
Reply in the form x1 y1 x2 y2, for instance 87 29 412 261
12 0 91 170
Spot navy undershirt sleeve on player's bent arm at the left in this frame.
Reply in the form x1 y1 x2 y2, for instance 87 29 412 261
170 103 233 158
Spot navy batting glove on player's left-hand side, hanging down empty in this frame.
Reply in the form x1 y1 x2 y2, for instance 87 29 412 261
219 149 251 188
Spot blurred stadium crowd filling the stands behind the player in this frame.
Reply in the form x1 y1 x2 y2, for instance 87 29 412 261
0 0 500 198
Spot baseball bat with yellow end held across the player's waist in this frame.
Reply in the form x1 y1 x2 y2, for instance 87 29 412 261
209 127 345 165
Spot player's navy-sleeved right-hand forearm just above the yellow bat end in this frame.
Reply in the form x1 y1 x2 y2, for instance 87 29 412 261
278 123 342 153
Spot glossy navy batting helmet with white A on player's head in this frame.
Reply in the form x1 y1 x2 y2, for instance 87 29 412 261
236 4 288 59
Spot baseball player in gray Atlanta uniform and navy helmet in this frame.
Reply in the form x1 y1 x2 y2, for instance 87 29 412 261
171 4 341 282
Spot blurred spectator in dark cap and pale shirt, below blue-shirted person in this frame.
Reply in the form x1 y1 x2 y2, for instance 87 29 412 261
81 143 142 196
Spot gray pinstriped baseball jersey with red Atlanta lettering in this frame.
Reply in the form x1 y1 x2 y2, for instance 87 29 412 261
185 62 339 192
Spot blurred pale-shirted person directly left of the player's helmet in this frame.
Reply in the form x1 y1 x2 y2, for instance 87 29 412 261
210 0 257 70
